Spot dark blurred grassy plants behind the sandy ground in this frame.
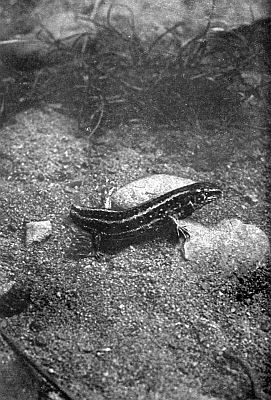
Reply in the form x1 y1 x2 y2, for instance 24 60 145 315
1 2 268 131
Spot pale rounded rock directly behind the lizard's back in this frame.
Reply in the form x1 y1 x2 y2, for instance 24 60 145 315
111 174 195 209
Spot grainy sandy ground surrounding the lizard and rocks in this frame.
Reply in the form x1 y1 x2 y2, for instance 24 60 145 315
0 107 271 400
